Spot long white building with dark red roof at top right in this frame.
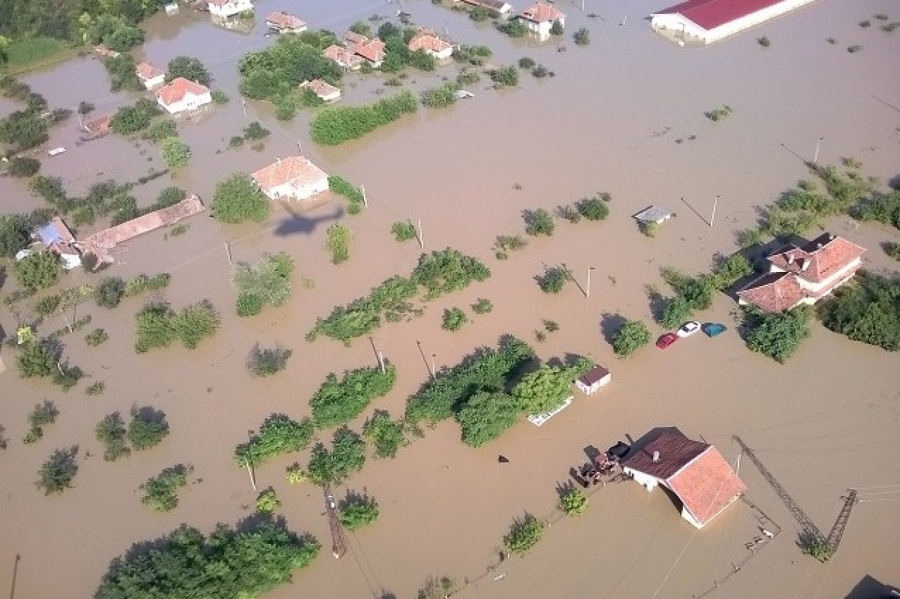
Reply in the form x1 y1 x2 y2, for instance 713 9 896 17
650 0 815 44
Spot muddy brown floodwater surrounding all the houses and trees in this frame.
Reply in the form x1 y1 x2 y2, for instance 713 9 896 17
0 0 900 599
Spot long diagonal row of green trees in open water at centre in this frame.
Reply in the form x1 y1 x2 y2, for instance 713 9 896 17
306 248 491 344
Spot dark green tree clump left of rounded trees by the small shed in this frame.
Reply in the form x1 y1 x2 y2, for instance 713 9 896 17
406 338 534 422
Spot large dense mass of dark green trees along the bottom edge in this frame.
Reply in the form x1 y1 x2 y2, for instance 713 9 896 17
95 518 321 599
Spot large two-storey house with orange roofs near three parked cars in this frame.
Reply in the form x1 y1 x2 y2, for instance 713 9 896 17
737 233 866 313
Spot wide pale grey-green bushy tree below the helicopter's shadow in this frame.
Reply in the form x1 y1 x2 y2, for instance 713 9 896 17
232 252 294 316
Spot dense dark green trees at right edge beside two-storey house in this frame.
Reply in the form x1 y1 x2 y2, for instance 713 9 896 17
820 272 900 351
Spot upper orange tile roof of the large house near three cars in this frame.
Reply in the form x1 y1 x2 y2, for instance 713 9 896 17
769 233 866 283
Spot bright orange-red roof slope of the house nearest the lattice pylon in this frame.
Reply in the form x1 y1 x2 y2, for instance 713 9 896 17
666 446 747 526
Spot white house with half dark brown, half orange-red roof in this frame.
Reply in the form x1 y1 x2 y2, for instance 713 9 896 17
621 432 747 528
